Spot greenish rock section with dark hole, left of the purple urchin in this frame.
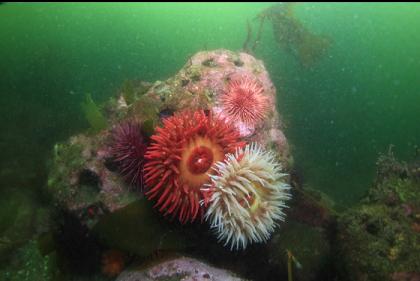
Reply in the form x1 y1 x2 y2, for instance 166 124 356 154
48 132 141 228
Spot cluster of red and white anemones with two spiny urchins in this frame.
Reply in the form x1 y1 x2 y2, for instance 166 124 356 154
113 79 290 249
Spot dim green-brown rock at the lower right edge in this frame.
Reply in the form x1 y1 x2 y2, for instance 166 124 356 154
336 151 420 280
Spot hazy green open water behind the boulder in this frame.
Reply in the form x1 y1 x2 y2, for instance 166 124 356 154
0 3 420 278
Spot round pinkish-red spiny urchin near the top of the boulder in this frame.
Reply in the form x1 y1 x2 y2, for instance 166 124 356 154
219 77 269 128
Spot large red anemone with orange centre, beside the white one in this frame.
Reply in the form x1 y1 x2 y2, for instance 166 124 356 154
144 110 244 223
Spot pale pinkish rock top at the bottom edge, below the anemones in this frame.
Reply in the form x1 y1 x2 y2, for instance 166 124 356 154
116 257 245 281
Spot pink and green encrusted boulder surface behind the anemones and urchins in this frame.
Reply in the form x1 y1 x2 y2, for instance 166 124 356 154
48 49 291 230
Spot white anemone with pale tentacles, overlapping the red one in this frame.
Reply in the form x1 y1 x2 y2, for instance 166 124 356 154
203 143 290 250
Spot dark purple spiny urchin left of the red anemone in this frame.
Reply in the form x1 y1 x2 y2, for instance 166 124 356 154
111 120 147 188
